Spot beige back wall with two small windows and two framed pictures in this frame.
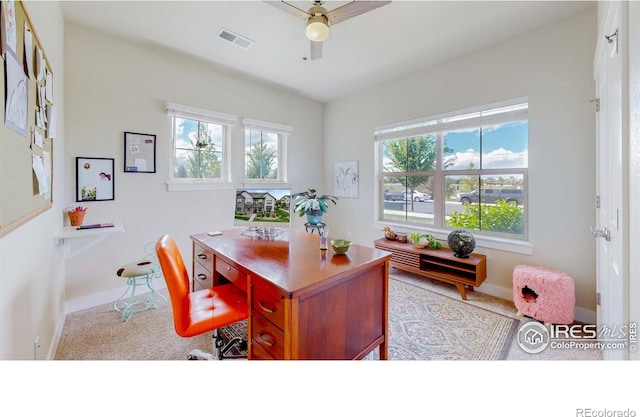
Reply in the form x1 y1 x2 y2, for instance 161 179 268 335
64 24 323 309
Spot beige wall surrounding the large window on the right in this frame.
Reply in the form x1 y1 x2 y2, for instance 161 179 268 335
324 8 596 320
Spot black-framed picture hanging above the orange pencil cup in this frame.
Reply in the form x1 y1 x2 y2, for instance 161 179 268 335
76 157 115 201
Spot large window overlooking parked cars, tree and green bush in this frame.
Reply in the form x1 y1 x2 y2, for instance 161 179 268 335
375 99 528 239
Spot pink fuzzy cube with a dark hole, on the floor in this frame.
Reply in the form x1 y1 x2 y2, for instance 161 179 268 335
513 265 576 324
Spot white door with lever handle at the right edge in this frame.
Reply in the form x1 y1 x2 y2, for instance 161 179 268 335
592 2 628 359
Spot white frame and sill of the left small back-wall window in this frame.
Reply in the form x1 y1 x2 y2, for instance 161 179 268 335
166 102 238 191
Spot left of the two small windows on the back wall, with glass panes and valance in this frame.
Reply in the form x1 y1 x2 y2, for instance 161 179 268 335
167 103 237 182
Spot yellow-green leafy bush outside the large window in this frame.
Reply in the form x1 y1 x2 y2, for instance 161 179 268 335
449 200 524 235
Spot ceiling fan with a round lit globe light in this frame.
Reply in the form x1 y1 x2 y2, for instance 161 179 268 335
267 0 391 60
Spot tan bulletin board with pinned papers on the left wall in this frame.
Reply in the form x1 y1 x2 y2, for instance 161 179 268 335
0 1 56 237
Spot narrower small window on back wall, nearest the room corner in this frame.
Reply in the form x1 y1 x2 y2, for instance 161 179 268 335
242 118 292 182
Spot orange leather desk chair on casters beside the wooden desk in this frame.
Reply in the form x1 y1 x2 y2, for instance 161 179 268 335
156 235 249 360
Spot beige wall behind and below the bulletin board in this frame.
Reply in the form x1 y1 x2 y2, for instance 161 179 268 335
0 2 65 359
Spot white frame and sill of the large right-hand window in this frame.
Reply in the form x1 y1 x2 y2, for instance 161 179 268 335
374 97 533 255
